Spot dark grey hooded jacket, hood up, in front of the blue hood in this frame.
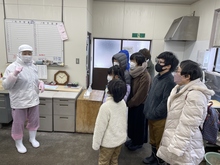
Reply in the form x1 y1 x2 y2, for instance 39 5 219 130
112 53 131 84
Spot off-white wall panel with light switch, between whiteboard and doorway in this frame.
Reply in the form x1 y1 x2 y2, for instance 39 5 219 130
61 7 87 86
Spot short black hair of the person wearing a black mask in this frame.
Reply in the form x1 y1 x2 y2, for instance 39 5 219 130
157 52 179 72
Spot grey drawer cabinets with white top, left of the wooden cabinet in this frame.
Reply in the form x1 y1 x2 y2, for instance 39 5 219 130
38 91 80 132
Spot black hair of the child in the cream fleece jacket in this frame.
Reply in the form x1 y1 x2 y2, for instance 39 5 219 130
108 79 127 103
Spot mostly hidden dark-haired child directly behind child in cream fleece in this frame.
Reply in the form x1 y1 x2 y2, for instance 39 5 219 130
103 65 131 102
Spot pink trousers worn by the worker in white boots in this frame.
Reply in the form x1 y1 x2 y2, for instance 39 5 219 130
11 105 39 140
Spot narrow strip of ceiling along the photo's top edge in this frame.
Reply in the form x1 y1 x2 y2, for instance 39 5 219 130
94 0 199 5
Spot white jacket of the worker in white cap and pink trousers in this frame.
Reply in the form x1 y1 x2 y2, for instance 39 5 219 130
2 57 40 109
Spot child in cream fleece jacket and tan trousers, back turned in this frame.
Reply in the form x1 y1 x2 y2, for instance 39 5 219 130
92 79 127 165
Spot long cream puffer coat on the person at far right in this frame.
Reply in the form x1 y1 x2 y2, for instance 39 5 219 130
157 79 214 165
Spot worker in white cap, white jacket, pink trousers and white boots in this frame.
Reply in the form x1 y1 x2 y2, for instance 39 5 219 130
2 44 44 153
